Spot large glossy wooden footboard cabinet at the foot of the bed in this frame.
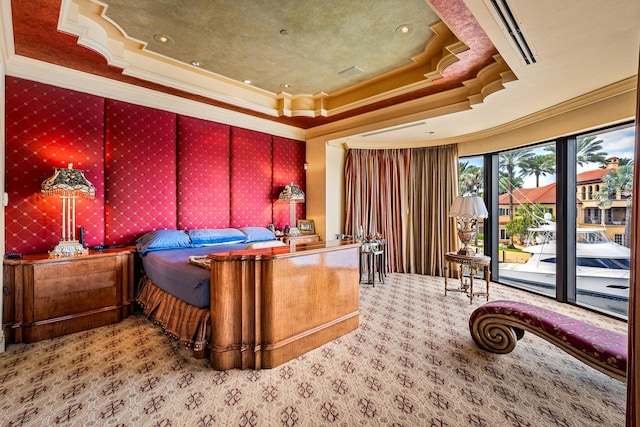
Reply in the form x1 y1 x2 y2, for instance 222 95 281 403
210 241 360 370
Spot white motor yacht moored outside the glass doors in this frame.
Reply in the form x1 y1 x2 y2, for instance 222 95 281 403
498 218 631 301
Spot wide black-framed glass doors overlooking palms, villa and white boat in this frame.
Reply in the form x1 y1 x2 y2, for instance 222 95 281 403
460 124 635 319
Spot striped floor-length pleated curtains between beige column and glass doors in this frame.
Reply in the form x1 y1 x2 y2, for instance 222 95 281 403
345 145 458 275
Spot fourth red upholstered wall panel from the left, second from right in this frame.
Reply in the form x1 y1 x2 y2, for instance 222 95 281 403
231 128 274 227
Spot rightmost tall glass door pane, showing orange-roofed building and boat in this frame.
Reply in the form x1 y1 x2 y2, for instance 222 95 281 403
576 126 634 317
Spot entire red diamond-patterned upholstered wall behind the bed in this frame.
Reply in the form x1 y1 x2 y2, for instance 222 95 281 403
5 77 305 253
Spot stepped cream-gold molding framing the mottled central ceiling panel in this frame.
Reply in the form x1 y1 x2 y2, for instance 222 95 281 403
58 0 510 118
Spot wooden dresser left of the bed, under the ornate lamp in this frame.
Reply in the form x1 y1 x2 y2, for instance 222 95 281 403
2 247 134 343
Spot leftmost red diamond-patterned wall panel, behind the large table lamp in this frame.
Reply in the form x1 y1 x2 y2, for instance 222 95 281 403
5 77 104 253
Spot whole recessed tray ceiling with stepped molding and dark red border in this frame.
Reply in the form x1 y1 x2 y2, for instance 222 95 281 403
11 0 508 129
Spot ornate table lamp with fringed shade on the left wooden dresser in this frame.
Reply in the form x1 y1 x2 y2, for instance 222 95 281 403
41 163 96 258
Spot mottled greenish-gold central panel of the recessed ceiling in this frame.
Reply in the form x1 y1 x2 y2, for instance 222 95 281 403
104 0 439 94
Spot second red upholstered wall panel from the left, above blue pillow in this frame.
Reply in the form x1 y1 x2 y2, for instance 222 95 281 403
105 100 176 245
